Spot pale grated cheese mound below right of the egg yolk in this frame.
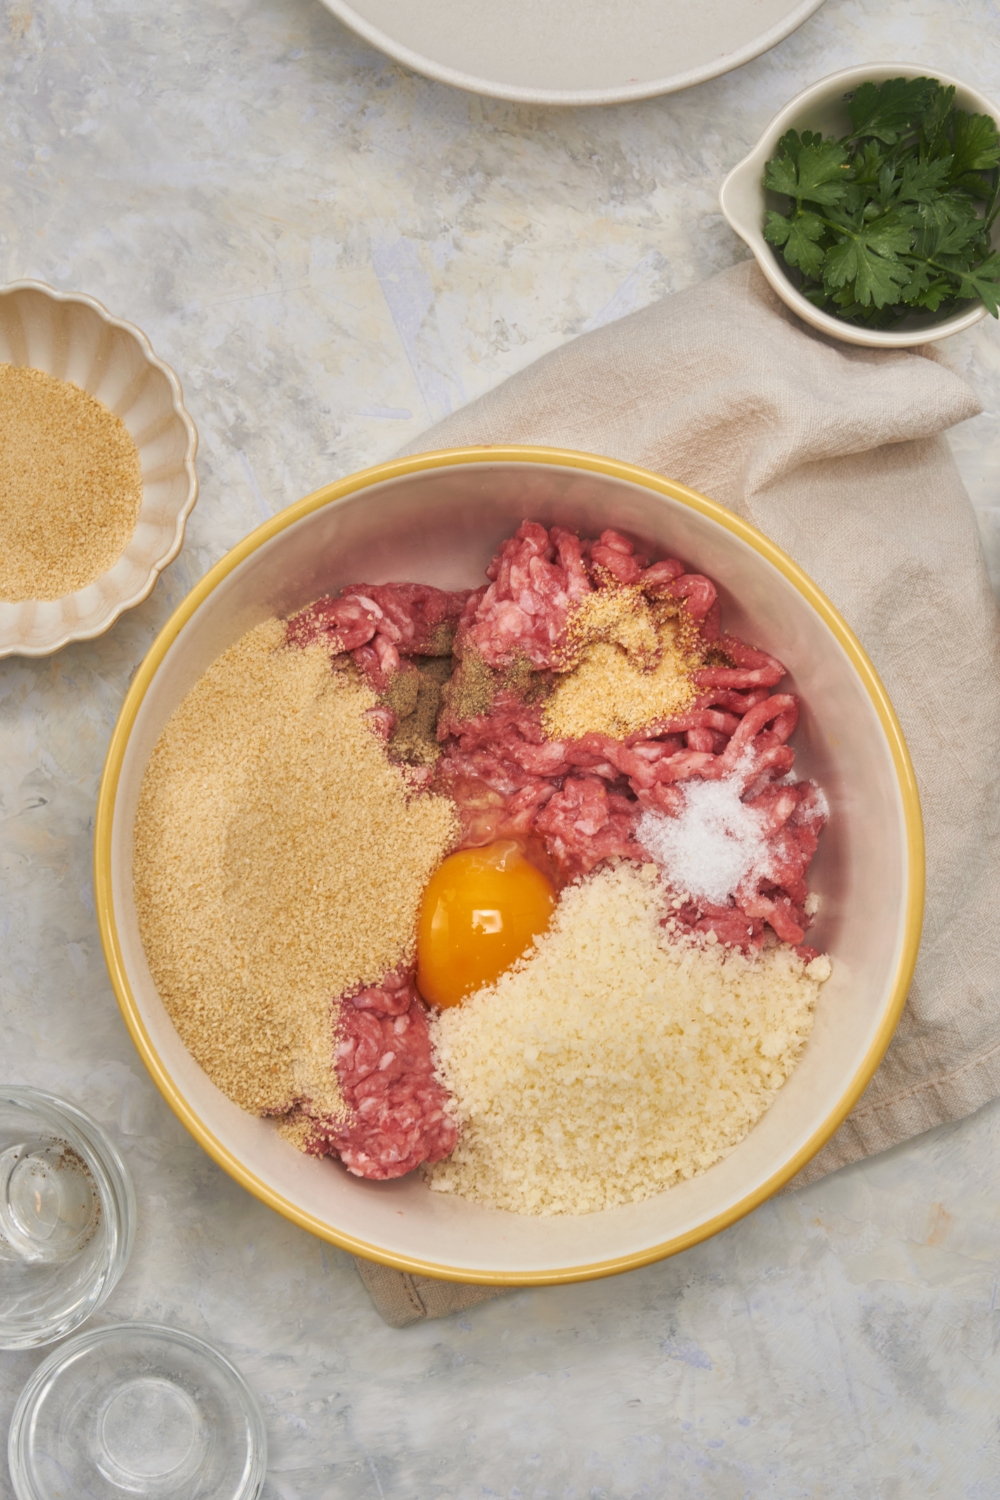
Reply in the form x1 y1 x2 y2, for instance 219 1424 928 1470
429 863 831 1214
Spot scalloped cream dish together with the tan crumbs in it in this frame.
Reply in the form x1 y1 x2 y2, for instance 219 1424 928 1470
0 282 198 657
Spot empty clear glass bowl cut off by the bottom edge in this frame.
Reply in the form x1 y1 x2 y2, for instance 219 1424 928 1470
7 1323 267 1500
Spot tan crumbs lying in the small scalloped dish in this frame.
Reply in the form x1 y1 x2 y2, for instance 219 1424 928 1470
0 365 142 603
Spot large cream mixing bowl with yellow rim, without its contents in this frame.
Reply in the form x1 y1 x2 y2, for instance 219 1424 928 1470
96 447 924 1284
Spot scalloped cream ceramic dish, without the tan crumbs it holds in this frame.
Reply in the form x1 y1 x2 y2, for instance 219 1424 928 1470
0 281 198 657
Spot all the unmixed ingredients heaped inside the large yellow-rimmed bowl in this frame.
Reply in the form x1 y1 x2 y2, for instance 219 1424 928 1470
133 521 832 1215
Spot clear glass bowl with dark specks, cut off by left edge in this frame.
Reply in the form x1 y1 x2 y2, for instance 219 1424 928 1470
0 1085 135 1349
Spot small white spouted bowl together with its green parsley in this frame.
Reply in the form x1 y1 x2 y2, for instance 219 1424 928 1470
720 63 1000 348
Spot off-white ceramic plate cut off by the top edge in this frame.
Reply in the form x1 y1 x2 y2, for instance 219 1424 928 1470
324 0 823 105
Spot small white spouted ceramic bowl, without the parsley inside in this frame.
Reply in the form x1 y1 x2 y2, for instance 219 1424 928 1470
718 63 1000 350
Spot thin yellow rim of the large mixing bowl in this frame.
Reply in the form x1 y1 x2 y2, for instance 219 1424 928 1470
94 446 924 1287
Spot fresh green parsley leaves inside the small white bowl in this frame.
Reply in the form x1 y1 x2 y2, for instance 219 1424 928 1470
765 78 1000 329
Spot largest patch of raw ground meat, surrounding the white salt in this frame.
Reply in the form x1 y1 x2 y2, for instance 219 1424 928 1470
436 522 826 957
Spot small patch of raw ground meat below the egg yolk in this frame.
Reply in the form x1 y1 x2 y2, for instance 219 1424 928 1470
293 974 459 1181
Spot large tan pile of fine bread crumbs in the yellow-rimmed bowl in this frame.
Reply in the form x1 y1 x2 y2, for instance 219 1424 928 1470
133 620 456 1116
